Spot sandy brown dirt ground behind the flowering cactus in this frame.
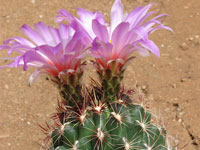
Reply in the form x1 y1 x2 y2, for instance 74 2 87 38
0 0 200 150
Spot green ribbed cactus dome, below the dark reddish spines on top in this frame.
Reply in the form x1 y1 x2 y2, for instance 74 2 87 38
52 103 166 150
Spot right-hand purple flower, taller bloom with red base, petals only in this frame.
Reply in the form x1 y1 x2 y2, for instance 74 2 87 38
56 0 172 67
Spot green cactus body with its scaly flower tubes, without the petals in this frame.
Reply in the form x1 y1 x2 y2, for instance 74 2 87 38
47 58 166 150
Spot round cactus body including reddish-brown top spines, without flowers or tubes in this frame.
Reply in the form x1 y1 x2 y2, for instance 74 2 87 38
47 87 166 150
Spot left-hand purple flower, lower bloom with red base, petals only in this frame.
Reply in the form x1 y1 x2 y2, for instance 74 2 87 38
0 22 86 84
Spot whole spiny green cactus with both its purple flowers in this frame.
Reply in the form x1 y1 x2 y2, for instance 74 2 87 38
0 0 171 150
